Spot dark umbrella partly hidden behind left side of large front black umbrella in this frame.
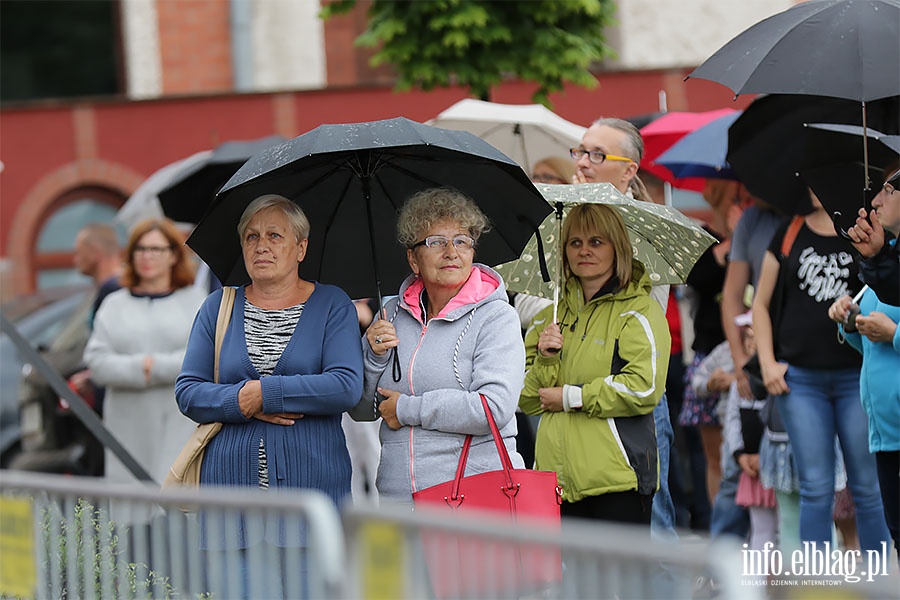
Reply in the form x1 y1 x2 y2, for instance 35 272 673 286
157 135 285 223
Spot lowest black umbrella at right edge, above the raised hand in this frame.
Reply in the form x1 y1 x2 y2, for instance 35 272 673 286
800 123 900 234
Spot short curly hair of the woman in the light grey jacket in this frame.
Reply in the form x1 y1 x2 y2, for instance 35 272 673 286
397 188 490 248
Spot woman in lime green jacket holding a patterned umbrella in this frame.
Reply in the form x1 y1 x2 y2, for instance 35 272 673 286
519 204 671 525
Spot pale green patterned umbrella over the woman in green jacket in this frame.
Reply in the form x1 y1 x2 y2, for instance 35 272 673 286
495 183 716 299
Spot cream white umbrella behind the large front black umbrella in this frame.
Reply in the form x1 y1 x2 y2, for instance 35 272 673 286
428 98 585 171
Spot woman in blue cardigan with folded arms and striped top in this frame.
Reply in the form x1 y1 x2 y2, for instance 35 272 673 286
175 194 362 596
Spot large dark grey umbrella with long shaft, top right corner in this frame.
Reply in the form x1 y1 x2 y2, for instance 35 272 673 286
688 0 900 209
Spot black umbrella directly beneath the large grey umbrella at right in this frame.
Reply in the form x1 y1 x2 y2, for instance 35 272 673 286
727 94 900 214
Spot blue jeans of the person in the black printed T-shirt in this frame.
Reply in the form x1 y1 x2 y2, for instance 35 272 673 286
776 366 890 552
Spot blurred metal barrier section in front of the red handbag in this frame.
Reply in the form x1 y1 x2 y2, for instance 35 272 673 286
344 503 764 600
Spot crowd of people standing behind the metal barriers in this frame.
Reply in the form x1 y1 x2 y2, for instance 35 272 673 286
59 112 900 592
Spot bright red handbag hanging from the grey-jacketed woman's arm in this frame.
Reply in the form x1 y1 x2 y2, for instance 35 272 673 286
412 395 562 598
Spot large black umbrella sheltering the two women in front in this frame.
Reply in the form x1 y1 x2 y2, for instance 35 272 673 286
187 118 551 298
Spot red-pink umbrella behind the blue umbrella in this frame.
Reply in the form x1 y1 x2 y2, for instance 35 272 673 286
641 108 735 192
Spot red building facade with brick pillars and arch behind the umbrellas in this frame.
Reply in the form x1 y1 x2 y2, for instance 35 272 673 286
0 0 750 298
